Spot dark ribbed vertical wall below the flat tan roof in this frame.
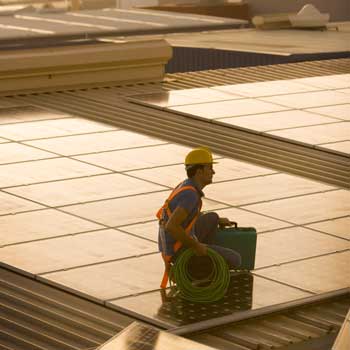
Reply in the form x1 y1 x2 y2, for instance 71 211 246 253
165 47 350 73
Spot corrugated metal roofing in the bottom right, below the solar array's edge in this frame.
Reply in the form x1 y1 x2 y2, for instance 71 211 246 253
183 292 350 350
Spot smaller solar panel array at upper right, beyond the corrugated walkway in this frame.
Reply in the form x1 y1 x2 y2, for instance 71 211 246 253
130 74 350 155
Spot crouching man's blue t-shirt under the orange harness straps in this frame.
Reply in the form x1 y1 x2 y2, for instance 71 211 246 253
158 179 203 256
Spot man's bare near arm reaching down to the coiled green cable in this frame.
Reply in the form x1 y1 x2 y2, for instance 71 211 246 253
165 207 207 255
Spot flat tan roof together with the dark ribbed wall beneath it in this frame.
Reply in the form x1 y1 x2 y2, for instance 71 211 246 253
104 22 350 73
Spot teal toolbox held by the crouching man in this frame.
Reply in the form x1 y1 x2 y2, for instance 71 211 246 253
214 222 256 270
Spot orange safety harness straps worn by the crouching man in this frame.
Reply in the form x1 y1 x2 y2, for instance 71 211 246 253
156 184 202 289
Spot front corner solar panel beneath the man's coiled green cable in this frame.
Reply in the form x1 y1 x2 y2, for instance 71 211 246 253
110 272 310 327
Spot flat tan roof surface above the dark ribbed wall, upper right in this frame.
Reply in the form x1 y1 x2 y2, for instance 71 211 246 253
126 22 350 56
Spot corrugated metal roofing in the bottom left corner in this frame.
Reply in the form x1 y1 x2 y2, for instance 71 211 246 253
0 268 134 350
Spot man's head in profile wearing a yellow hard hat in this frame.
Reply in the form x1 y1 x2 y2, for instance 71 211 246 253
185 148 216 188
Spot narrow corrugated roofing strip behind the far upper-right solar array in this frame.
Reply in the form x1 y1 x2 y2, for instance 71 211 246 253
0 58 350 96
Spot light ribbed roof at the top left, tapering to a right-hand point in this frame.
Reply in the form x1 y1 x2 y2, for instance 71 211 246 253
0 9 247 48
